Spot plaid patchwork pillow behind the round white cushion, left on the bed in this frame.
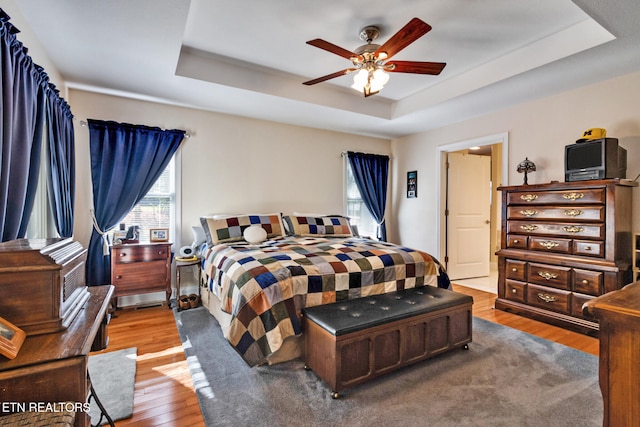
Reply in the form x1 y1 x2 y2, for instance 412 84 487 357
200 214 284 245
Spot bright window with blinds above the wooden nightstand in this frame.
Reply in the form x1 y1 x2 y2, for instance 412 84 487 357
122 156 176 242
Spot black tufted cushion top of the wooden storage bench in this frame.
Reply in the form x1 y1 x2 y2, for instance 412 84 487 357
302 286 473 336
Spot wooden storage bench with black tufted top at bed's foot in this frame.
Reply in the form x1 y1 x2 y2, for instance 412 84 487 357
303 286 473 399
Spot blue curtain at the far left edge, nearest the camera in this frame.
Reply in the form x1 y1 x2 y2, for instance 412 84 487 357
0 9 46 242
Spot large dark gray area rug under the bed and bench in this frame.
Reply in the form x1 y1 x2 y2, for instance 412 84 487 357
174 307 603 427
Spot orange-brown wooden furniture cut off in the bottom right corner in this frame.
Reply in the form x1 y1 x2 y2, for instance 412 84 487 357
584 282 640 427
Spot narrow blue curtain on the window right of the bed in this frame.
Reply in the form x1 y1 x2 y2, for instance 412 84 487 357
347 151 389 242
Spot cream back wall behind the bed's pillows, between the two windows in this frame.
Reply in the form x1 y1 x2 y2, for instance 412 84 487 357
69 89 393 251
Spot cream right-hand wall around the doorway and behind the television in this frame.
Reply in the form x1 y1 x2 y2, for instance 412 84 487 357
392 73 640 256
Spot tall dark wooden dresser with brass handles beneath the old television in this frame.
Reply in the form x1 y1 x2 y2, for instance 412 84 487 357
495 179 637 335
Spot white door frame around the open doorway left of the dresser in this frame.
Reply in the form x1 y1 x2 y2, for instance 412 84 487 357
436 132 509 264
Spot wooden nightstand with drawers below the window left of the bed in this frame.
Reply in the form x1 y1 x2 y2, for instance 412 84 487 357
111 243 171 308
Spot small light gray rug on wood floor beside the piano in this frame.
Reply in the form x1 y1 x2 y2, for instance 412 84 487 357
89 347 137 424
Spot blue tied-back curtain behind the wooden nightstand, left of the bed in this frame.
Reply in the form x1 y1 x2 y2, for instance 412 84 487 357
87 119 185 285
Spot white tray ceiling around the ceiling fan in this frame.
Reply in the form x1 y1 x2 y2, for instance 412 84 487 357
11 0 640 138
